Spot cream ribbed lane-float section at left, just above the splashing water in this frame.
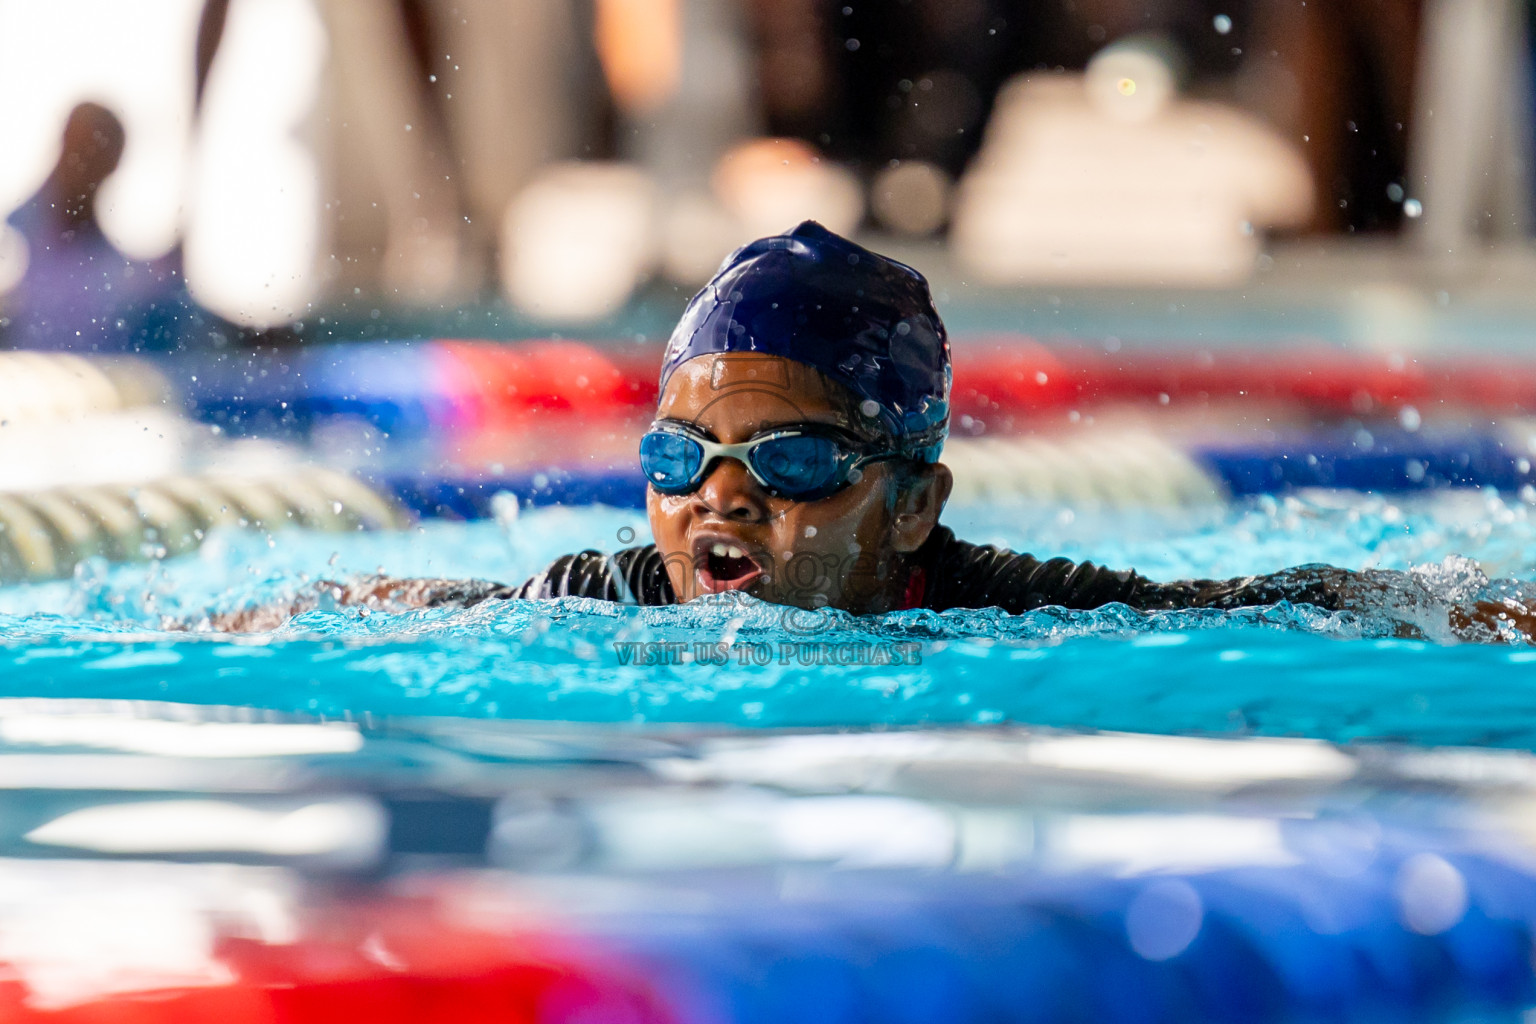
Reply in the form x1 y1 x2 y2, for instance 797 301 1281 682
0 467 410 583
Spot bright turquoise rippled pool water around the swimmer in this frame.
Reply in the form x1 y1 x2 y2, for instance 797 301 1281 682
9 493 1536 749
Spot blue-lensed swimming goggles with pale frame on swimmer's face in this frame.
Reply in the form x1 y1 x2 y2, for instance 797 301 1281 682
641 421 900 502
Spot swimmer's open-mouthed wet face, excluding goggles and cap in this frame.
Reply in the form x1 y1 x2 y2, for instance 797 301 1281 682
647 353 949 613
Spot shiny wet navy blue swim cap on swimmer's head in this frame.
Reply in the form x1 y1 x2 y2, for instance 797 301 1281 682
660 221 951 462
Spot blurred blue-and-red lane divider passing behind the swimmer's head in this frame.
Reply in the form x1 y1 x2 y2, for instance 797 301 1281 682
161 335 1536 439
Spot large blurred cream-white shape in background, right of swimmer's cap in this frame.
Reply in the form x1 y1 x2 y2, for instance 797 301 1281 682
952 37 1313 286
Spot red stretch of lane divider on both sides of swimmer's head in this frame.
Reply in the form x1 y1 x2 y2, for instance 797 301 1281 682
438 335 1536 428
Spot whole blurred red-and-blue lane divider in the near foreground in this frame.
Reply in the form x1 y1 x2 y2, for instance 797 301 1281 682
9 847 1536 1024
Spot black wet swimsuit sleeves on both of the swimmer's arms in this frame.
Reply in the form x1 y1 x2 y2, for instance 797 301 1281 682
451 527 1359 614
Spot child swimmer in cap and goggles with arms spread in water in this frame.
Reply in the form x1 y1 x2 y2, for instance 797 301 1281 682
214 221 1536 640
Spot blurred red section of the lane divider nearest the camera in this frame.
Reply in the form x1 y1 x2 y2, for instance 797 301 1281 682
0 900 674 1024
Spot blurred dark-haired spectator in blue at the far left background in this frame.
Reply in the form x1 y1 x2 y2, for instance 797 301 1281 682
0 103 184 352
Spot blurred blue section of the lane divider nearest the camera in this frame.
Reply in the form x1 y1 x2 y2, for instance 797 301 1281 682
593 837 1536 1024
